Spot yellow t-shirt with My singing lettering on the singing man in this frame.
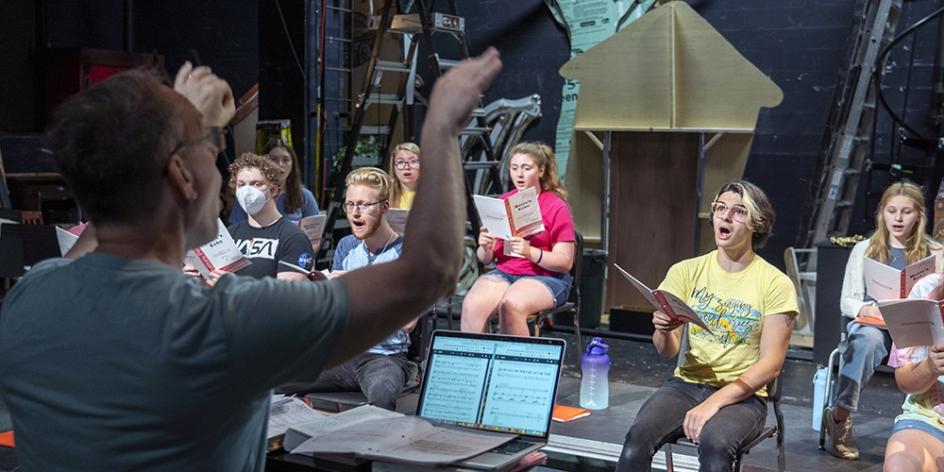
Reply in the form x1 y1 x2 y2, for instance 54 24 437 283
659 250 797 397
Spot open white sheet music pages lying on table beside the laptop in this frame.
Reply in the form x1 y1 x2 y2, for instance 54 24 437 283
283 405 515 465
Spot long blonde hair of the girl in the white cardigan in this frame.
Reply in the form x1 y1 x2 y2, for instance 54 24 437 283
865 180 937 264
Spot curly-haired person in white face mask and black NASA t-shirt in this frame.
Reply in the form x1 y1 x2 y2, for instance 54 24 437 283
228 153 314 280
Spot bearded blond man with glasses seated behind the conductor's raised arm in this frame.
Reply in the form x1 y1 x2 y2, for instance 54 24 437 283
282 167 417 410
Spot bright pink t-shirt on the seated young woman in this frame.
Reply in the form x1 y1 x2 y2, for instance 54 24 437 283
495 189 580 275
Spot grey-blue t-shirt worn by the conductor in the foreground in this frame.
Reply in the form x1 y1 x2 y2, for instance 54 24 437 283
0 253 349 471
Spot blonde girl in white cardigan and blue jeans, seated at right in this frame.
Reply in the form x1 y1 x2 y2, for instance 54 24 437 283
823 182 941 460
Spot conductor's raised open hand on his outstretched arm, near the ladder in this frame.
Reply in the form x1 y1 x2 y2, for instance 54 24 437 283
426 48 502 130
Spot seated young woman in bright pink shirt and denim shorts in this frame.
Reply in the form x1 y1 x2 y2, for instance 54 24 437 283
462 142 575 336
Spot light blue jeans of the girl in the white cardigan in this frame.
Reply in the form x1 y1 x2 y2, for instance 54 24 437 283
836 321 892 411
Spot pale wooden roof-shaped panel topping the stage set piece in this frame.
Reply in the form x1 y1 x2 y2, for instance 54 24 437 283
560 1 783 133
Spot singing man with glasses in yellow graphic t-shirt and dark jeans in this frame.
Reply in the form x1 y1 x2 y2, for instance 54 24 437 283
616 181 797 472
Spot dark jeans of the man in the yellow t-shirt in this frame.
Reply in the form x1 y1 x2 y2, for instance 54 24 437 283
616 377 767 472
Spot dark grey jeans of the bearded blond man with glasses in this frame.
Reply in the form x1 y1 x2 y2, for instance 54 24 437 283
279 352 416 410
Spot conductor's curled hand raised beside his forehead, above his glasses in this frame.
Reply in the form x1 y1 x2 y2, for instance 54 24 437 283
174 61 236 127
